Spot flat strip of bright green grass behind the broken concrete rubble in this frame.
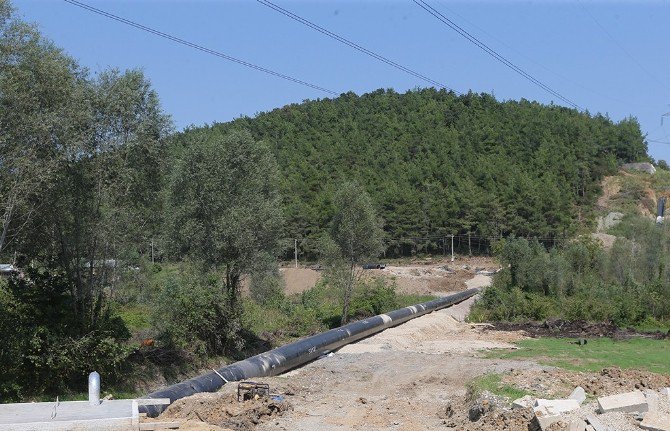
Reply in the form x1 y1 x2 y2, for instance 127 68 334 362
489 338 670 374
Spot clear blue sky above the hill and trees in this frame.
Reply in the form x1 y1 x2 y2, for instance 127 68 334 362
13 0 670 161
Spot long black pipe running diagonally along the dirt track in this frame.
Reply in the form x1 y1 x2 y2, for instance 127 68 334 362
143 288 479 417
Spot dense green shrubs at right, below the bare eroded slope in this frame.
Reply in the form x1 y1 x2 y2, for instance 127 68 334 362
470 217 670 328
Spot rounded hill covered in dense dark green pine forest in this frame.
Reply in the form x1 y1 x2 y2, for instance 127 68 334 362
178 89 648 254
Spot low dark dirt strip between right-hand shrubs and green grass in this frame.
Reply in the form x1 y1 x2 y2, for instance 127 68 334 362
489 319 670 339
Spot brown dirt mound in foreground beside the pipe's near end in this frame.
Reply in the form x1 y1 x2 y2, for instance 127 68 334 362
160 393 292 431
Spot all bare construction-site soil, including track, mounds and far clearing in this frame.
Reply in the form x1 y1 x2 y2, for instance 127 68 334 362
158 262 670 431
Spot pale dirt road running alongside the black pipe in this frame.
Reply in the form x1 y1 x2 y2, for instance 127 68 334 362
247 278 538 431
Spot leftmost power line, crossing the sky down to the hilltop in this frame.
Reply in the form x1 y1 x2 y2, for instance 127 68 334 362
63 0 339 96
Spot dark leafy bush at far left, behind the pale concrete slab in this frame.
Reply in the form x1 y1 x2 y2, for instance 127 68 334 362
0 268 131 400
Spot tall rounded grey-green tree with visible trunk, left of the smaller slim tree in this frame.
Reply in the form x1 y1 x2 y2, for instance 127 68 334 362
165 131 283 304
